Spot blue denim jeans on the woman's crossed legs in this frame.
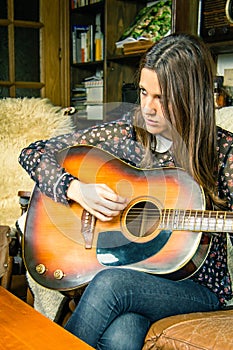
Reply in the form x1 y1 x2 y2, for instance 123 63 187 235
65 268 219 350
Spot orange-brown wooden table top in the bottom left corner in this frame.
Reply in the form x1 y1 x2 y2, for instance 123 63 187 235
0 287 93 350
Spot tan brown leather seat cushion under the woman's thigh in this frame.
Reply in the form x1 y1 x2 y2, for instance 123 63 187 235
142 310 233 350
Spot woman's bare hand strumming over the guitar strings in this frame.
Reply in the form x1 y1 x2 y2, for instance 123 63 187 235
67 180 127 221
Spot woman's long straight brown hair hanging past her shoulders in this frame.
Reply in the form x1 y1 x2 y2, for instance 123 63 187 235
135 34 219 208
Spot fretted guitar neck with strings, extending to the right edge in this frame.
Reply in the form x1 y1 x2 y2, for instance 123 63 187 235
160 209 233 233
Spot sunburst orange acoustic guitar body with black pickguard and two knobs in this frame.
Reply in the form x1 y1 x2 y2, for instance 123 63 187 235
23 145 210 291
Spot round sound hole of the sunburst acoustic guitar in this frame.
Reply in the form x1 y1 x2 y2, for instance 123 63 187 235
125 200 160 237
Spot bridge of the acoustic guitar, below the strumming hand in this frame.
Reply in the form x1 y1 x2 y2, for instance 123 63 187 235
81 209 96 249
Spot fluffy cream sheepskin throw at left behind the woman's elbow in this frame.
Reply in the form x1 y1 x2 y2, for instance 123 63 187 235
0 98 73 227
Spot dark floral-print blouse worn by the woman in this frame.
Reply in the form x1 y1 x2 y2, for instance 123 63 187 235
19 115 233 305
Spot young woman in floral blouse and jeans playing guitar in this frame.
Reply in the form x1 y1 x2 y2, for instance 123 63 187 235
20 34 233 350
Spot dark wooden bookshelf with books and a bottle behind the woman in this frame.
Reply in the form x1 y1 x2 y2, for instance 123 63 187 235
70 0 178 125
